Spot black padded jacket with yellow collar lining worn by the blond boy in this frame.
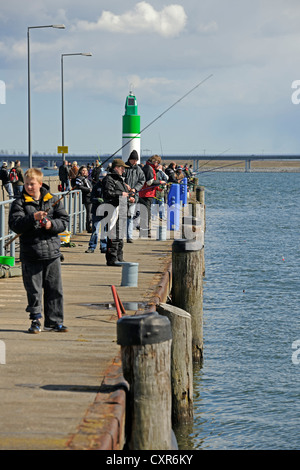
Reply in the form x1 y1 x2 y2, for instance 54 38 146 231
8 184 69 261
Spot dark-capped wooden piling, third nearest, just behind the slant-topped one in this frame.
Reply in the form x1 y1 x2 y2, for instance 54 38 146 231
172 239 203 362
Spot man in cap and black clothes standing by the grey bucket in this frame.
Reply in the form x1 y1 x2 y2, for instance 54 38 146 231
102 158 129 266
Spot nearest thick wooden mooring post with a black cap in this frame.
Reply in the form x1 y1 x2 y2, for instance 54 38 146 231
117 312 177 450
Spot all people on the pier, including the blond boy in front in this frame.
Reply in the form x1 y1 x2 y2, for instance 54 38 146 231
0 157 193 334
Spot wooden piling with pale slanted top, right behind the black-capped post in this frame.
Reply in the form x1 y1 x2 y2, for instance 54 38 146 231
156 303 193 425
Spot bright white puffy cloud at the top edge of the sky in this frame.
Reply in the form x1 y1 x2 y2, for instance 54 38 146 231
75 2 187 37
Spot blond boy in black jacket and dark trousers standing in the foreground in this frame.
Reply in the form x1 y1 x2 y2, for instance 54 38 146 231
9 168 69 333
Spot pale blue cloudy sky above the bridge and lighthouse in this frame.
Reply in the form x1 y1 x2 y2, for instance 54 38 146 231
0 0 300 156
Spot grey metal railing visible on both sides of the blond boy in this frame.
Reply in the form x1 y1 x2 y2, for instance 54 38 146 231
0 190 86 256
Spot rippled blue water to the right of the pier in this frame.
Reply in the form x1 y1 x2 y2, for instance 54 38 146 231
177 172 300 450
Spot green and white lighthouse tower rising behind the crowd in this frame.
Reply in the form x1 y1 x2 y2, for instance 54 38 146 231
122 91 141 162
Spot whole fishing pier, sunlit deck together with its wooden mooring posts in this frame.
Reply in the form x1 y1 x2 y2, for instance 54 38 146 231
0 174 205 450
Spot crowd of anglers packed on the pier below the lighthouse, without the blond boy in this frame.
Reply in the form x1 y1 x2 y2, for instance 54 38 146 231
59 150 193 266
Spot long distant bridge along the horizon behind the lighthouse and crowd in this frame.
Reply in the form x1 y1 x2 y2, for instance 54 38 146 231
0 152 300 171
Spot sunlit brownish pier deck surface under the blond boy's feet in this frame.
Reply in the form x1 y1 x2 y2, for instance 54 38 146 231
0 232 172 450
